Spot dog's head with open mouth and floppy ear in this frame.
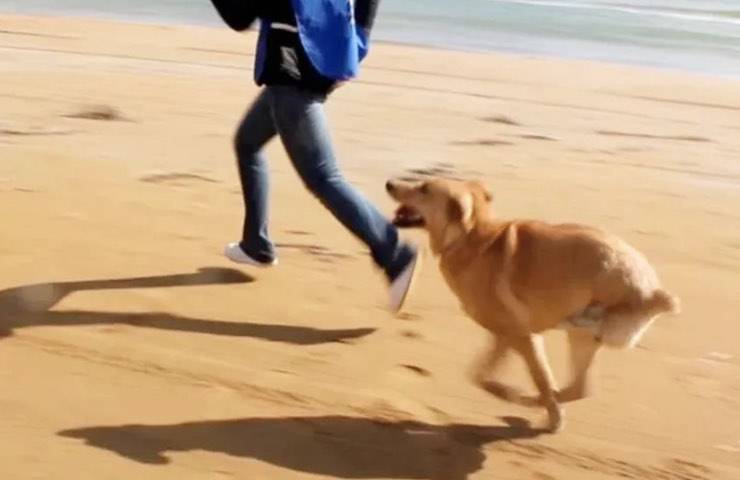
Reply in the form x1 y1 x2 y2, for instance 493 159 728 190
386 178 492 253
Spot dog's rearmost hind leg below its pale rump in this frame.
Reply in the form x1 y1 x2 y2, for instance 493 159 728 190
556 329 601 402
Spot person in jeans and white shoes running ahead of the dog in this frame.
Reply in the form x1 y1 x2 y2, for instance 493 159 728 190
213 0 419 312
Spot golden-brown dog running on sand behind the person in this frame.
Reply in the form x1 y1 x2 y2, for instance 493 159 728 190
386 178 680 433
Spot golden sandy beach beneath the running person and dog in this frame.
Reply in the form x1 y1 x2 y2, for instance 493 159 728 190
0 16 740 480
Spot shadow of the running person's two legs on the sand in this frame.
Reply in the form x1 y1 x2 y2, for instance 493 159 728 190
0 268 375 345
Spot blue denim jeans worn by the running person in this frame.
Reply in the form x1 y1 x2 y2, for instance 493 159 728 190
235 86 414 280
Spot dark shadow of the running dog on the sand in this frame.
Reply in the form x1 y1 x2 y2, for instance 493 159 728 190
59 416 541 480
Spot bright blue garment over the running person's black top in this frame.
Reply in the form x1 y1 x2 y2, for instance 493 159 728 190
255 0 369 81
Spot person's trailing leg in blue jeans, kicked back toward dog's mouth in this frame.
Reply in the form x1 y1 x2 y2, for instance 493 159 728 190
268 87 416 294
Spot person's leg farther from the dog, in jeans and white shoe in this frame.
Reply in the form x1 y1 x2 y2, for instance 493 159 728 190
226 89 277 266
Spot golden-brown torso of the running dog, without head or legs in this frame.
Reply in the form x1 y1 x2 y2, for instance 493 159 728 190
442 221 677 346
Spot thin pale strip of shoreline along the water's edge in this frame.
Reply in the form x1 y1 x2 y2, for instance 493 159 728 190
0 10 740 81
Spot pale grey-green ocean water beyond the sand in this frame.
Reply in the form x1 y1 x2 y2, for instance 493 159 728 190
0 0 740 76
